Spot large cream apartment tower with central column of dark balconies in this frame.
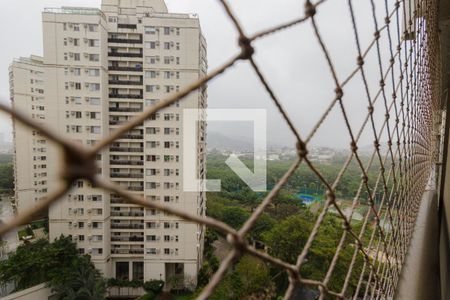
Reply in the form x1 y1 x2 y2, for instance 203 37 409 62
13 0 207 284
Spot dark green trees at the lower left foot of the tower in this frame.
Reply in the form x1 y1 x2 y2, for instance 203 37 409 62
0 236 106 300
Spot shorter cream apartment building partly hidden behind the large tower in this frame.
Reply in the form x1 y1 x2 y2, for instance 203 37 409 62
9 56 48 211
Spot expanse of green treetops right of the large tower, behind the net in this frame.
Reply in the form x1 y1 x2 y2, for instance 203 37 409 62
194 154 378 299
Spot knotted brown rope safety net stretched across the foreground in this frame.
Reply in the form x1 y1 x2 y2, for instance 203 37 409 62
0 0 441 299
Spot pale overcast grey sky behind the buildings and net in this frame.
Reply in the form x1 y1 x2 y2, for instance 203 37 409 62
0 0 401 148
